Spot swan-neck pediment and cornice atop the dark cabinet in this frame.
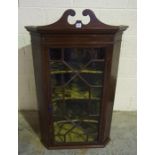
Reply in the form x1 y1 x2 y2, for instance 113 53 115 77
26 9 127 34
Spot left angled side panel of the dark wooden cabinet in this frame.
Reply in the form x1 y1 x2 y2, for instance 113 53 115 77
31 34 49 146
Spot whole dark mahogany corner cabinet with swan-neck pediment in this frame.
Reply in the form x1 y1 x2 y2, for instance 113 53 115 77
26 9 127 149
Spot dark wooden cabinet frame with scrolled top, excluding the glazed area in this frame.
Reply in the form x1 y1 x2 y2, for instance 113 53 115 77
26 9 127 149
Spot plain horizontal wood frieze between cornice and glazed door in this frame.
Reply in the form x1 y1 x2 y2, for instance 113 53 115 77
43 34 114 47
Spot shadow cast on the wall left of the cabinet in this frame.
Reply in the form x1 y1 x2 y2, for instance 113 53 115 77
18 45 37 110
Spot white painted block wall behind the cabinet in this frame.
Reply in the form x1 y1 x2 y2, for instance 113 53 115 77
18 0 137 110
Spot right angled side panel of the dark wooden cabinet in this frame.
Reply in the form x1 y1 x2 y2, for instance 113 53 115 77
104 33 122 138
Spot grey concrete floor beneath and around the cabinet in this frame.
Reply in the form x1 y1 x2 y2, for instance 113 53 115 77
19 111 137 155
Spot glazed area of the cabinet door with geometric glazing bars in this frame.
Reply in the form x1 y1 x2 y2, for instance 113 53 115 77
49 48 105 145
